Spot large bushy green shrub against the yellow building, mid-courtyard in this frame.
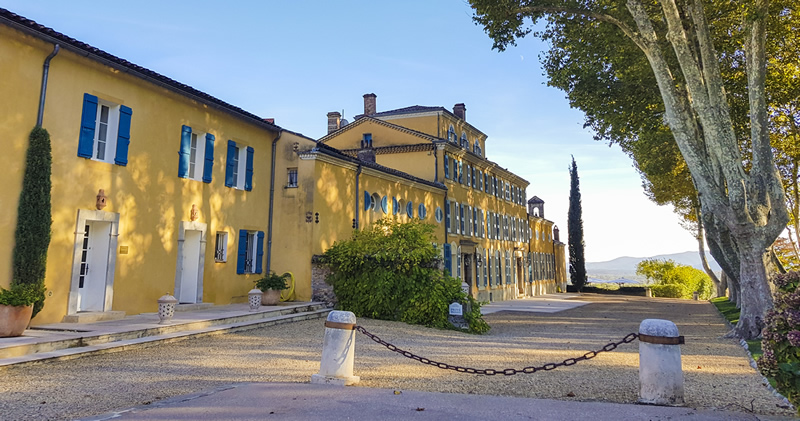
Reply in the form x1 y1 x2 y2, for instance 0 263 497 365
322 220 489 333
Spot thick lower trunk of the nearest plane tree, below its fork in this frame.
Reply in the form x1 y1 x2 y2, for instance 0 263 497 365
733 243 772 339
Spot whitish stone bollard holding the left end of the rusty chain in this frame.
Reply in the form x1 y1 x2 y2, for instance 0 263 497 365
311 310 360 386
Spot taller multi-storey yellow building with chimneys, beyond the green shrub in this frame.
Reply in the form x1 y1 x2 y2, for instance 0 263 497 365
319 94 566 301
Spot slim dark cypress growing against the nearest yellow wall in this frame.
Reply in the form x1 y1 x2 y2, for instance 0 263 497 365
11 126 53 315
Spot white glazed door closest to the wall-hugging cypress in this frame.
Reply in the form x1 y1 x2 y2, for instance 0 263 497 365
78 221 111 311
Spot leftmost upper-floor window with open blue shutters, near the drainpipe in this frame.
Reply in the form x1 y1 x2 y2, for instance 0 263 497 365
78 94 133 166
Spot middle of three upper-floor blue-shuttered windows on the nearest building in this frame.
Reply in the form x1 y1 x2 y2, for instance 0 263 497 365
178 125 214 183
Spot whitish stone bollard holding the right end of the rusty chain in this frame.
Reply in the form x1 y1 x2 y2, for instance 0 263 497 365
639 319 685 406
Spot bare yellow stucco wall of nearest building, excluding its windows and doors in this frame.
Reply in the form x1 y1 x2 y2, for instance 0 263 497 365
0 27 282 324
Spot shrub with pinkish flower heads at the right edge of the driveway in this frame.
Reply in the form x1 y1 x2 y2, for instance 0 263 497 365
758 271 800 414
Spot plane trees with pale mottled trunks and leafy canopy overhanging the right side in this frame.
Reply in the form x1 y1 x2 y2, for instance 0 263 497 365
470 0 800 338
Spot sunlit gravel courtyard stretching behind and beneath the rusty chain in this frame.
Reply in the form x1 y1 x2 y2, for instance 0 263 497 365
0 294 793 420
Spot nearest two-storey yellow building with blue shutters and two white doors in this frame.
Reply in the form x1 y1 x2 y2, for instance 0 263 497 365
0 9 296 324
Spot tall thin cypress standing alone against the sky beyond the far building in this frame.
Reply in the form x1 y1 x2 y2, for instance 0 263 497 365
567 156 586 292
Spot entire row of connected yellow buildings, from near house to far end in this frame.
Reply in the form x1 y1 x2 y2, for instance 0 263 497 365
0 9 566 324
